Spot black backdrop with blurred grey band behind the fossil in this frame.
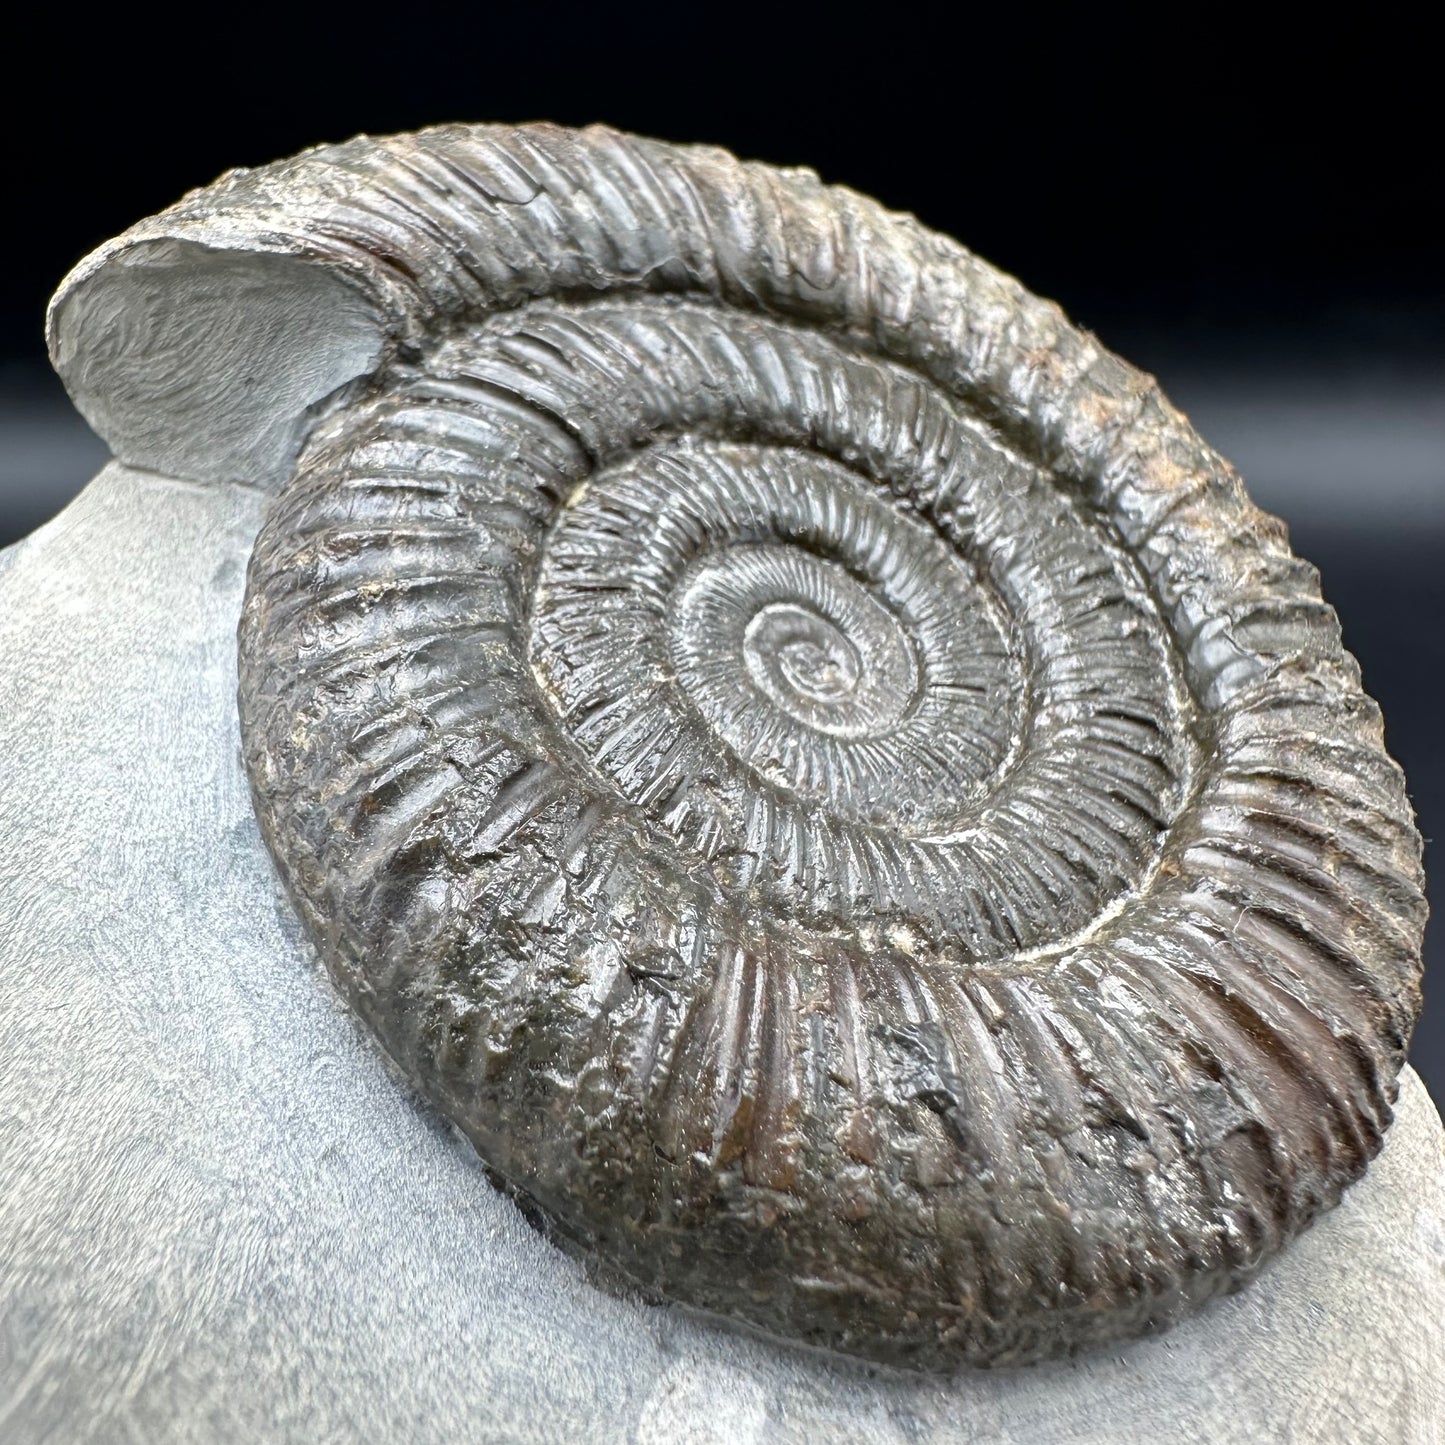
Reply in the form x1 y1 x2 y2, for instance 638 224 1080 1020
0 11 1445 1098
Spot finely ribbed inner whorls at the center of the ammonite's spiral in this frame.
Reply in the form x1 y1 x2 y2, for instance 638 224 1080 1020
532 441 1022 838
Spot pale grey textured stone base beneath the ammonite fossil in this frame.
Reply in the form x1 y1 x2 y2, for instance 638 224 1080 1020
0 467 1445 1445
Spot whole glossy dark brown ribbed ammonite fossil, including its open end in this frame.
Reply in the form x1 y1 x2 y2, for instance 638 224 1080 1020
55 126 1423 1366
